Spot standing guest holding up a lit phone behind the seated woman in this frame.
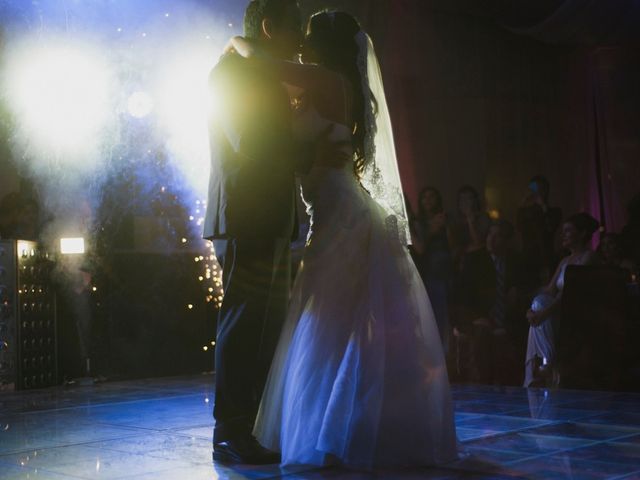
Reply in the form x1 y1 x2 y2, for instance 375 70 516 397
517 175 562 282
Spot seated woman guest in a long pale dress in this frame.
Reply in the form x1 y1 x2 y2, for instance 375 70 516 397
524 213 599 387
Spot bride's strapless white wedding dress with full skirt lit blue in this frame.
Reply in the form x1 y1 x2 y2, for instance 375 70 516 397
254 65 456 468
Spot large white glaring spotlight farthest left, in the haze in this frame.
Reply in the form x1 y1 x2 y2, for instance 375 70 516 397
8 44 109 155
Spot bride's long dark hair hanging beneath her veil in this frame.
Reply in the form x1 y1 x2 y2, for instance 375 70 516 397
306 10 377 175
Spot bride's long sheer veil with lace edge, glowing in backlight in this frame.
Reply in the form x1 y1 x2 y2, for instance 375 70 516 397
356 31 411 245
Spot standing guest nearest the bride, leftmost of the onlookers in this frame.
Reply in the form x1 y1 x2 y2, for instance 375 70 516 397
413 187 453 353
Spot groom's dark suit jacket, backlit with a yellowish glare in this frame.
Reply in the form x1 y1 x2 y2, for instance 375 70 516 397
203 53 303 242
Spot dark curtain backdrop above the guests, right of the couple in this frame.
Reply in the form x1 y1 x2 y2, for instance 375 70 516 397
302 0 640 230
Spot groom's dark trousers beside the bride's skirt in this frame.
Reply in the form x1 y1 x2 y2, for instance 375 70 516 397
213 238 291 443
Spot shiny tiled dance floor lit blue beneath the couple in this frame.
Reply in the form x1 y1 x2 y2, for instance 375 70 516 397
0 376 640 480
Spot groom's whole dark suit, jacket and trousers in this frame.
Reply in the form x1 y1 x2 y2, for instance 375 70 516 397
204 54 308 442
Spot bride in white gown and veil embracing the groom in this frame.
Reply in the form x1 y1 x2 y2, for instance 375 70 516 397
231 12 457 468
